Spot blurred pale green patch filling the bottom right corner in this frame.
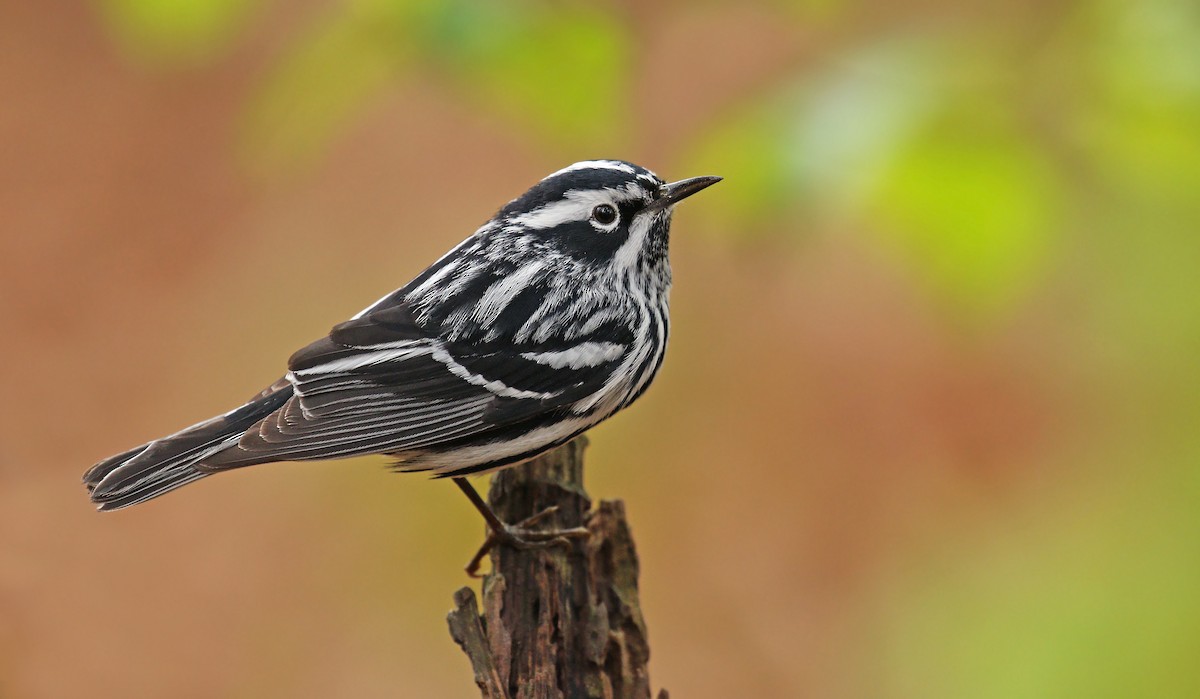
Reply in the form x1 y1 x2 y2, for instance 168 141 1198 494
866 463 1200 699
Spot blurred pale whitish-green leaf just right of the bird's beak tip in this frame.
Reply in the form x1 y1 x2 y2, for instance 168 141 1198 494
683 42 931 233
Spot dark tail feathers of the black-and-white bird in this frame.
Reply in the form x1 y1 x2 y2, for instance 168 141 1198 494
83 380 292 512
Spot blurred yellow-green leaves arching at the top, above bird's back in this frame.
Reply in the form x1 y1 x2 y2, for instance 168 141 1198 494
238 0 629 165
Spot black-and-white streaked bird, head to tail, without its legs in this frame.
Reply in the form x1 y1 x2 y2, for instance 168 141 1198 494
84 160 720 518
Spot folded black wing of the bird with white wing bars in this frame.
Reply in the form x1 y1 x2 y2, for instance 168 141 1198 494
198 295 629 472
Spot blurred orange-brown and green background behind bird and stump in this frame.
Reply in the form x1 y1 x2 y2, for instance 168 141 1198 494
0 0 1200 699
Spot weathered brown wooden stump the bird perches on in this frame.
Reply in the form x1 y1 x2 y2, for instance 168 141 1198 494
448 437 666 699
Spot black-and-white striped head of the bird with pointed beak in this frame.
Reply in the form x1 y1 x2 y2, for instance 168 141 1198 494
497 160 721 276
